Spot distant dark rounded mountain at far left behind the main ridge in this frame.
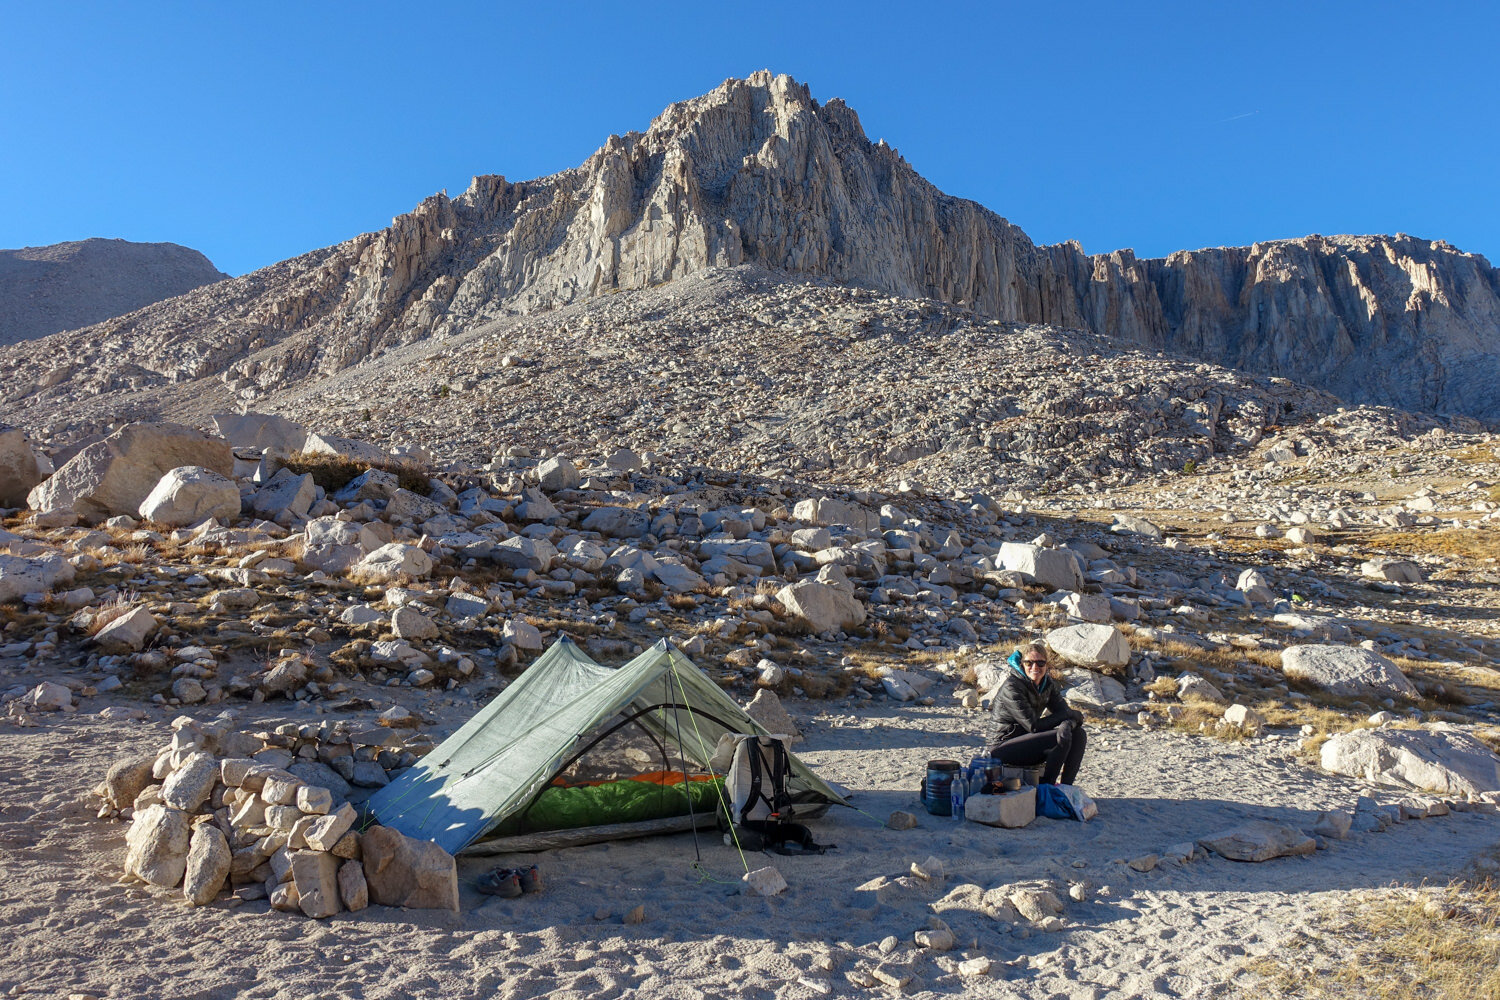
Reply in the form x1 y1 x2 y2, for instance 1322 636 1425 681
0 240 228 345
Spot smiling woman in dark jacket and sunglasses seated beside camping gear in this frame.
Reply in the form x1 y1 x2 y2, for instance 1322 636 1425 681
990 640 1088 784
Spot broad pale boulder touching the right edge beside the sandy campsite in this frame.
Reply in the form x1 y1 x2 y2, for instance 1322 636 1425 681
1322 724 1500 796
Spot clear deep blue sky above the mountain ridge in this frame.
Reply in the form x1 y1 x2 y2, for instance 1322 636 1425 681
0 0 1500 274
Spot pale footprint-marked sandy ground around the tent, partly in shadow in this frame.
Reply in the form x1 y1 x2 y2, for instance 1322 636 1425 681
0 699 1500 1000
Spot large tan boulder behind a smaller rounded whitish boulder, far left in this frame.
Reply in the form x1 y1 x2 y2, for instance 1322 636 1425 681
27 423 239 522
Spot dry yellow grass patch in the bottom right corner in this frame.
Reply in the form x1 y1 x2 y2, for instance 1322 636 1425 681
1245 877 1500 1000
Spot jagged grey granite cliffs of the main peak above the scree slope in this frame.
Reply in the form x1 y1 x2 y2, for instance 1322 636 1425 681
0 72 1500 421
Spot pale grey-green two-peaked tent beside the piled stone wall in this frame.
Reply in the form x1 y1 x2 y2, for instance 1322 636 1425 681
369 636 849 853
